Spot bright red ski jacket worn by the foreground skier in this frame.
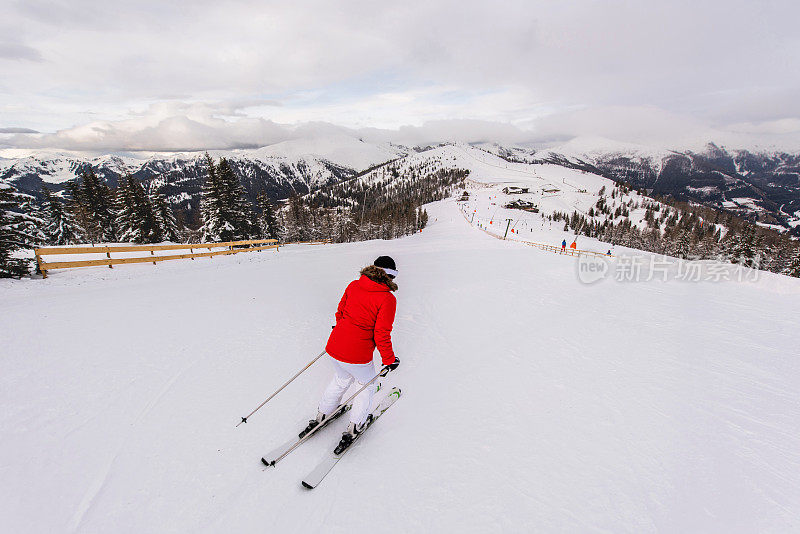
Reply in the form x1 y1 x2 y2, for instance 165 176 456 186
325 274 397 365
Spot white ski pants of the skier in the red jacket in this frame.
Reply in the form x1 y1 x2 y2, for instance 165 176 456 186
319 356 378 425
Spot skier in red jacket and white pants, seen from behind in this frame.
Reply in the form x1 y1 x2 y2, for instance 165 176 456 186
301 256 400 451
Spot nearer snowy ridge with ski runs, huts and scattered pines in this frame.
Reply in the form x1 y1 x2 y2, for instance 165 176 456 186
310 144 797 272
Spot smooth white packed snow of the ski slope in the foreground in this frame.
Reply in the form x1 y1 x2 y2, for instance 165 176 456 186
0 201 800 533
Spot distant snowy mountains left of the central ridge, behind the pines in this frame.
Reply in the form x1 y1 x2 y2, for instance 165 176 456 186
0 136 407 207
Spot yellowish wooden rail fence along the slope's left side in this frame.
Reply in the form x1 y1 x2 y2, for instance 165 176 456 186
34 239 279 278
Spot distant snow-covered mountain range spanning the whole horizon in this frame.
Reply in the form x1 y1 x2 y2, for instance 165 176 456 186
6 133 800 232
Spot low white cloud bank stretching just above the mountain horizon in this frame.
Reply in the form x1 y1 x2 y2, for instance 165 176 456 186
0 101 800 156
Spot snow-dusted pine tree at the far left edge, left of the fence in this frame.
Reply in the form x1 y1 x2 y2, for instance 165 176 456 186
0 181 44 278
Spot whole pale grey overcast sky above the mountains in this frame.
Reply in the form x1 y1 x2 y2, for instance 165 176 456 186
0 0 800 151
